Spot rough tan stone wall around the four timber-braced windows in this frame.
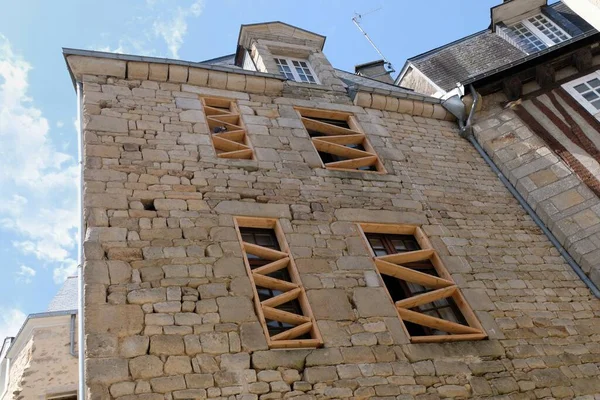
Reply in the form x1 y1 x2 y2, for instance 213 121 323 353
83 75 600 400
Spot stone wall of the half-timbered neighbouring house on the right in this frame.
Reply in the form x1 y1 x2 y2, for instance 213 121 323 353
475 88 600 285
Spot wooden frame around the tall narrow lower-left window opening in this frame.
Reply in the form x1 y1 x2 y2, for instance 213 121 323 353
233 216 323 349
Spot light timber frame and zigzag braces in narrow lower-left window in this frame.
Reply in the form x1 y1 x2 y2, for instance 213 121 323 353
235 217 323 348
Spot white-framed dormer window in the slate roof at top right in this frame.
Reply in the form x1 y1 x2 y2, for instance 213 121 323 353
508 14 571 54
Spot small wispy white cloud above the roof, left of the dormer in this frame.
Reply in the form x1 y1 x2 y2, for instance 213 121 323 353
150 0 204 58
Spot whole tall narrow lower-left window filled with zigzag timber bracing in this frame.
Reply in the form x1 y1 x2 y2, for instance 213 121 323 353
235 217 323 348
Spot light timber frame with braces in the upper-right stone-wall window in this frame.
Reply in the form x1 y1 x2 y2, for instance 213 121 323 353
294 107 387 174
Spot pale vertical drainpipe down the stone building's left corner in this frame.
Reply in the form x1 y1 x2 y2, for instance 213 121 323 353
76 81 86 399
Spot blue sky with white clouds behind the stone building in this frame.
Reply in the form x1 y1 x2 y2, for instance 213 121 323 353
0 0 501 338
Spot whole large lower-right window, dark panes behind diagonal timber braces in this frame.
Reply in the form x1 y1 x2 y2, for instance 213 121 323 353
360 224 487 343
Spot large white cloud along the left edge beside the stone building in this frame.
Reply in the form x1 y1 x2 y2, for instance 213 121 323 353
0 34 79 284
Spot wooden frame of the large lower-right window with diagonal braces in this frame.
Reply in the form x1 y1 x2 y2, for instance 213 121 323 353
357 223 487 343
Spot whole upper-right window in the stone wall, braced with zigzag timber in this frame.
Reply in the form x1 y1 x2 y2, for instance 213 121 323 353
296 107 385 173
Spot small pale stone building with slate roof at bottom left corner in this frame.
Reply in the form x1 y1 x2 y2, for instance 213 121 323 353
0 277 78 400
